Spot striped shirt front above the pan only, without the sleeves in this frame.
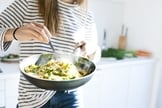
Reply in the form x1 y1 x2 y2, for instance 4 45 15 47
20 0 91 59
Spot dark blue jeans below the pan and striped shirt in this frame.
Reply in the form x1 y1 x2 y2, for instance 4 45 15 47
42 91 83 108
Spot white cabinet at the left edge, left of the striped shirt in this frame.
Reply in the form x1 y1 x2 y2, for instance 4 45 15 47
0 63 19 108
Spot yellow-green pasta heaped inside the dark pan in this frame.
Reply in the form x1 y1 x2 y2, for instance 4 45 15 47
24 59 84 80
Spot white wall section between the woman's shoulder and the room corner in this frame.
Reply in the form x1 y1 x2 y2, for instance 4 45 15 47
89 0 124 47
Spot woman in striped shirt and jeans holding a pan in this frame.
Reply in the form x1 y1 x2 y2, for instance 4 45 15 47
0 0 100 108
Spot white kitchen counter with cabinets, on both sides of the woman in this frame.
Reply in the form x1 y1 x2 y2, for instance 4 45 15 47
0 57 156 108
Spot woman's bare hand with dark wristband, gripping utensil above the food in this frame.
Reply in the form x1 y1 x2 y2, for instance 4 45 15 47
5 22 51 43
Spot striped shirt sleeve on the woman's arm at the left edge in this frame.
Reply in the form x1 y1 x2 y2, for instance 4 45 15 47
0 0 28 51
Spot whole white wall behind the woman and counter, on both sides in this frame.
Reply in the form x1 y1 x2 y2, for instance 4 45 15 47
0 0 162 108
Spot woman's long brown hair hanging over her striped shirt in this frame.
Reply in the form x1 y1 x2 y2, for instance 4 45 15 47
38 0 87 35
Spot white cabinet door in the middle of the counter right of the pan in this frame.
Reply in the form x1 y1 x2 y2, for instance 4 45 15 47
99 66 129 108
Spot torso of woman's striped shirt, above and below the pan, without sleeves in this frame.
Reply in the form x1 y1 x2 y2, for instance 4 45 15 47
19 0 91 108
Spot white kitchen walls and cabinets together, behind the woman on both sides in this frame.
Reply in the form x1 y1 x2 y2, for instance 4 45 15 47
0 0 162 108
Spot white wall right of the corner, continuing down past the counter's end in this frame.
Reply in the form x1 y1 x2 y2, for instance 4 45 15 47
124 0 162 108
